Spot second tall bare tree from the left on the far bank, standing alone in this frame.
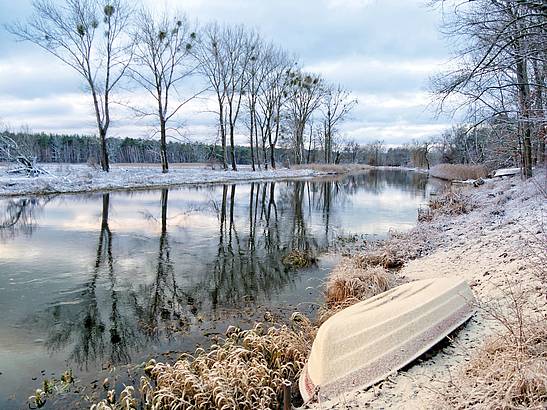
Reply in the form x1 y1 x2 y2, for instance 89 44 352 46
130 9 199 173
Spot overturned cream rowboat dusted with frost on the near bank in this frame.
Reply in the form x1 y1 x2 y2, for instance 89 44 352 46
299 277 475 402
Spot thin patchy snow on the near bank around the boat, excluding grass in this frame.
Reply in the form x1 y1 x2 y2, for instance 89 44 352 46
312 174 547 409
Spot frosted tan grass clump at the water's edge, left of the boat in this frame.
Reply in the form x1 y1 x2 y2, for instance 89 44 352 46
92 314 316 410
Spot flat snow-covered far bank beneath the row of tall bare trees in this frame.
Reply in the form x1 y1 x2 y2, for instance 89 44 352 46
0 164 324 196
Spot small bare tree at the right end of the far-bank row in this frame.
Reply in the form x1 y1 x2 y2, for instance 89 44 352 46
321 85 357 164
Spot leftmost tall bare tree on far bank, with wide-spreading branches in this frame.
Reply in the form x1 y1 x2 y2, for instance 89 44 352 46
8 0 132 172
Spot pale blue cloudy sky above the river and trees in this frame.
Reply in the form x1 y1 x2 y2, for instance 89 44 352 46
0 0 450 145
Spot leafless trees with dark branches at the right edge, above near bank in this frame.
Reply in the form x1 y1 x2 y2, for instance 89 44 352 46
431 0 547 177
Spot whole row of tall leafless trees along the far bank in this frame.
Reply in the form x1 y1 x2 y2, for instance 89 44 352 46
7 0 356 172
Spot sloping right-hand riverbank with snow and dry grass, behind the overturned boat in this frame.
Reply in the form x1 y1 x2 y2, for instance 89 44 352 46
312 175 547 409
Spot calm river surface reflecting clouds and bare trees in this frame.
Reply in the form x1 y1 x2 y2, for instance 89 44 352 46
0 171 444 409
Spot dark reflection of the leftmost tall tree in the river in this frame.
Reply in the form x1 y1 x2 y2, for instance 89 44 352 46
36 194 138 369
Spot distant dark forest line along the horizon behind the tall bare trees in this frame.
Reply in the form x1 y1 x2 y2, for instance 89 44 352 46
5 127 524 169
